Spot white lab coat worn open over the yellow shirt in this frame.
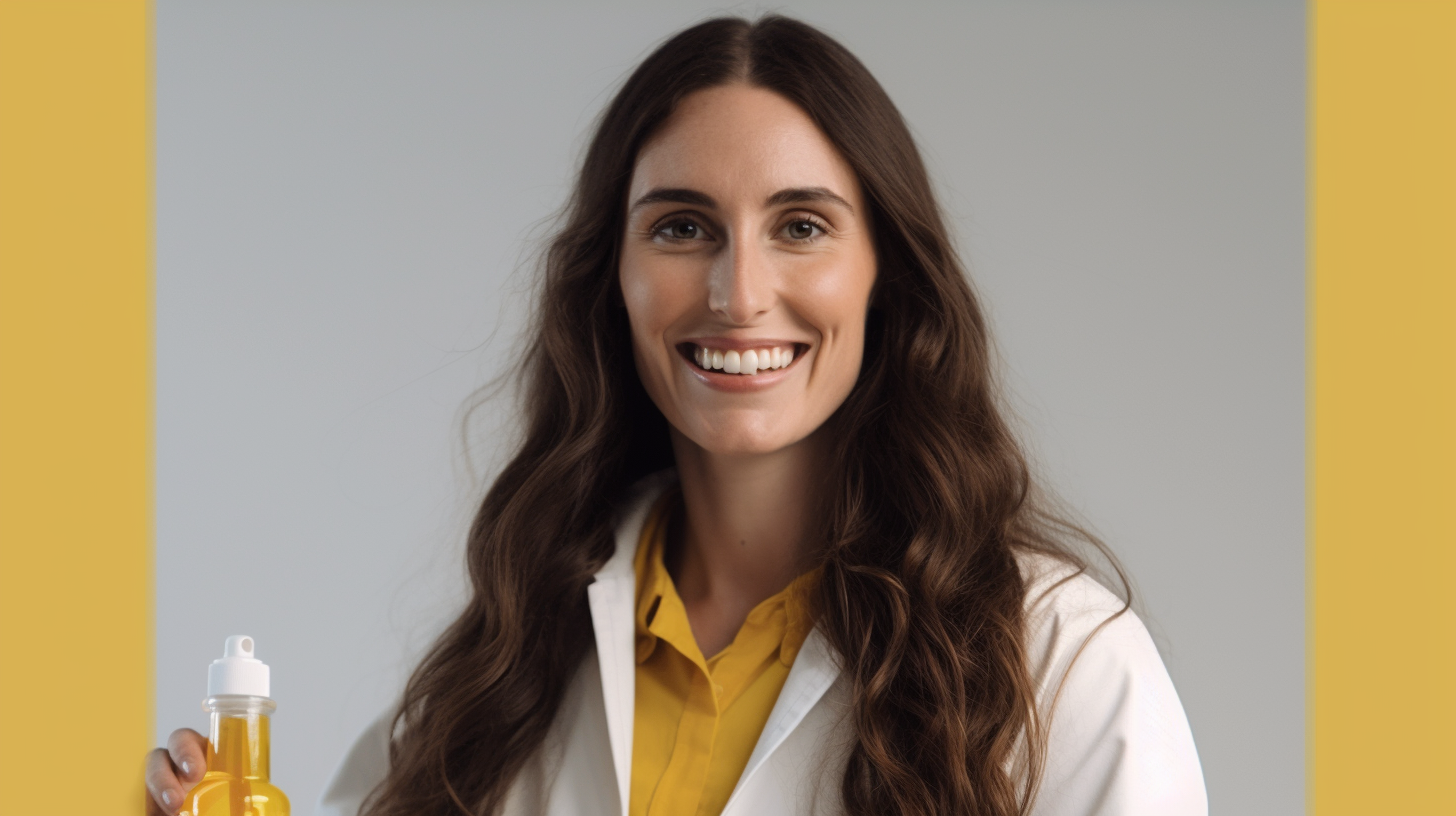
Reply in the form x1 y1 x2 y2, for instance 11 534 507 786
317 472 1208 816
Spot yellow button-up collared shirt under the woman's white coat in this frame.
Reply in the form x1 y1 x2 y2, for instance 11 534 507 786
628 490 815 816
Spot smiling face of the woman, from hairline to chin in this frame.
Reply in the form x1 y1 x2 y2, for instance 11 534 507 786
619 85 875 453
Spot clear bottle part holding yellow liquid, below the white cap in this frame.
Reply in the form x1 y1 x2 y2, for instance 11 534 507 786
178 697 288 816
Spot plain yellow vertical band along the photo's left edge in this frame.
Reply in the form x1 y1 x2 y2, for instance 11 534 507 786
0 0 153 816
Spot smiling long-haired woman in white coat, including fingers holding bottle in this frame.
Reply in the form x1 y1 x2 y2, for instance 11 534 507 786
149 16 1207 816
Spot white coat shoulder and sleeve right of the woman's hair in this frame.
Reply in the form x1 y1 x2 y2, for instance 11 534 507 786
1018 555 1208 816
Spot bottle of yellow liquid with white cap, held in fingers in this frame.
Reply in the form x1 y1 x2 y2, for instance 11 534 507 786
178 635 288 816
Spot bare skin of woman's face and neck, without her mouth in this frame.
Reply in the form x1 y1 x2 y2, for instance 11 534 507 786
619 85 877 656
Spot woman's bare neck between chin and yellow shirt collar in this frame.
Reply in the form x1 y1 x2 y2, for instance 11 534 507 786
668 430 824 657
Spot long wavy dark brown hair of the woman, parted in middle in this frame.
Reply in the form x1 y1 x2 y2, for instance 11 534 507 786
367 15 1124 816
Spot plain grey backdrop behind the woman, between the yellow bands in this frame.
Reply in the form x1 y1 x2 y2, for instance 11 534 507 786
156 0 1305 815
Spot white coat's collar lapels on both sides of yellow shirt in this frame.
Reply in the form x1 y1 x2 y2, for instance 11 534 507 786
587 469 839 816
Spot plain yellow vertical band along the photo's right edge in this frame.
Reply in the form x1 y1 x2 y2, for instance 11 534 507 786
1309 0 1456 816
